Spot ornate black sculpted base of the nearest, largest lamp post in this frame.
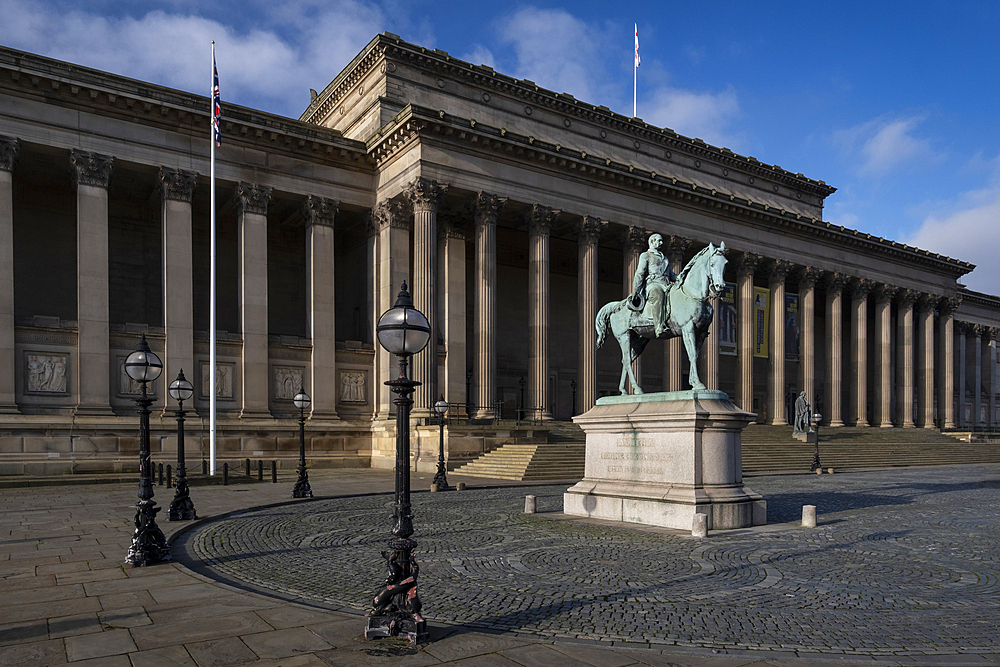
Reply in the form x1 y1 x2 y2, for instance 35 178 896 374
365 539 430 644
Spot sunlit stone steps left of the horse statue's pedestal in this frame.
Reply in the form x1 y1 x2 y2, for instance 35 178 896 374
452 422 587 481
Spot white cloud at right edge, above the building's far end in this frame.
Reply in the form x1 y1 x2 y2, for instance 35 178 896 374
906 157 1000 295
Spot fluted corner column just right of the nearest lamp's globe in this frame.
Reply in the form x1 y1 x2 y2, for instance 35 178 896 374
403 178 448 418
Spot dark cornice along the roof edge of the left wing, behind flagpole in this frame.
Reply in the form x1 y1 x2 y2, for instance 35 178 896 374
0 47 370 168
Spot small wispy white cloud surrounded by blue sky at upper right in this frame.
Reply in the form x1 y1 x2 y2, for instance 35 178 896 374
833 117 943 176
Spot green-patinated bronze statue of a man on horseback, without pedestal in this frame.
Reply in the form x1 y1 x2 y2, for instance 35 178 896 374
595 240 727 394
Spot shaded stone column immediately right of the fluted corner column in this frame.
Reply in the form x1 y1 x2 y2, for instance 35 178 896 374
438 218 468 417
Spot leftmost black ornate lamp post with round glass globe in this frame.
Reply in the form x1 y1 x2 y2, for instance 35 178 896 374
125 334 170 567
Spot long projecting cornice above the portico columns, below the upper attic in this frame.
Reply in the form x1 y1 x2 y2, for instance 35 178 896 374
368 104 975 279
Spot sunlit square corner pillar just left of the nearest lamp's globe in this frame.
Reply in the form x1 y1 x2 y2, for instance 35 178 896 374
371 200 412 419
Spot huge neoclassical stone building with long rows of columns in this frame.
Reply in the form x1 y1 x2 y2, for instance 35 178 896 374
0 33 1000 472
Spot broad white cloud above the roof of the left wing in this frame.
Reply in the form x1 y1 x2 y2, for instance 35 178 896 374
0 0 386 116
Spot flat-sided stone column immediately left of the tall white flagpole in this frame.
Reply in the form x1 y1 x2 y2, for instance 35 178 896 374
158 167 198 411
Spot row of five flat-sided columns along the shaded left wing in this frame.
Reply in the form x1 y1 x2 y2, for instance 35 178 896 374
0 137 337 419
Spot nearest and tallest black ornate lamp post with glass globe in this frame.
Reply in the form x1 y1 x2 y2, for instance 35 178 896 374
365 282 431 643
